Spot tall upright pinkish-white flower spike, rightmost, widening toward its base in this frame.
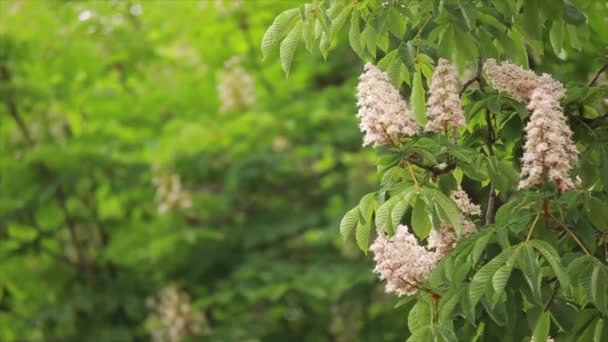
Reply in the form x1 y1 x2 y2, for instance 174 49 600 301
519 88 578 193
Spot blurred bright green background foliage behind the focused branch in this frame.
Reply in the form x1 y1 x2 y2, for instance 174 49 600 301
0 0 405 341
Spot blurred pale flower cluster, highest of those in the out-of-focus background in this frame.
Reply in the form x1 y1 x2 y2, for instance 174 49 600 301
217 57 256 113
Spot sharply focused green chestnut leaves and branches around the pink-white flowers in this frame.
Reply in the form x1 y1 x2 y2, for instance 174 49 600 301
261 0 608 341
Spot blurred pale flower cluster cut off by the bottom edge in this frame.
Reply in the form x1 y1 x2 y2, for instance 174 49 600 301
148 286 207 342
